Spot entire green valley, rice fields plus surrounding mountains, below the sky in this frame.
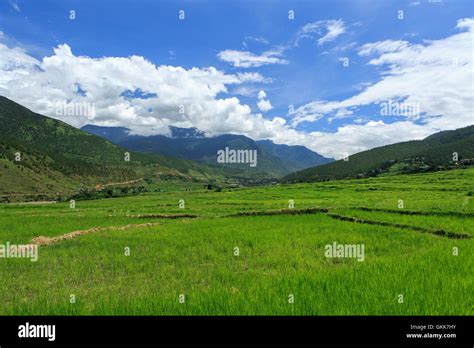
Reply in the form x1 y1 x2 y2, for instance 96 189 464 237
0 98 474 315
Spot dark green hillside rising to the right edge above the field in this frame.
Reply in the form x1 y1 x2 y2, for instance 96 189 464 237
282 126 474 182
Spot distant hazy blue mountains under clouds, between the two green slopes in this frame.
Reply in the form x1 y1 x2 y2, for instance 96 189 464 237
81 125 334 177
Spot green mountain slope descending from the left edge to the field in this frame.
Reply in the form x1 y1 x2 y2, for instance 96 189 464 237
0 96 223 200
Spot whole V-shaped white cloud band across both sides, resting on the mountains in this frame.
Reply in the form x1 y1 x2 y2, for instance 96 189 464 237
0 19 474 158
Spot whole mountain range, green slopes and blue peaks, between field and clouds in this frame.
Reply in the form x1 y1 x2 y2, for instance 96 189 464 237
0 96 474 201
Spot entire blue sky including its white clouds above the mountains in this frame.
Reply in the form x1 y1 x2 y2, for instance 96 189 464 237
0 0 474 157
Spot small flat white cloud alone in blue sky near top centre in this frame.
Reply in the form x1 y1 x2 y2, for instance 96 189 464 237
217 50 288 68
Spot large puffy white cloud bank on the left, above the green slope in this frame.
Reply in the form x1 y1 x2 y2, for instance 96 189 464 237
0 44 294 143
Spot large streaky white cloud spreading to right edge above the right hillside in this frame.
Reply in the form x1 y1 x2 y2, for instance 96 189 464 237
291 18 474 156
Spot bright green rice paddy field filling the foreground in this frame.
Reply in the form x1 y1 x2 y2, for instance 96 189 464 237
0 168 474 315
